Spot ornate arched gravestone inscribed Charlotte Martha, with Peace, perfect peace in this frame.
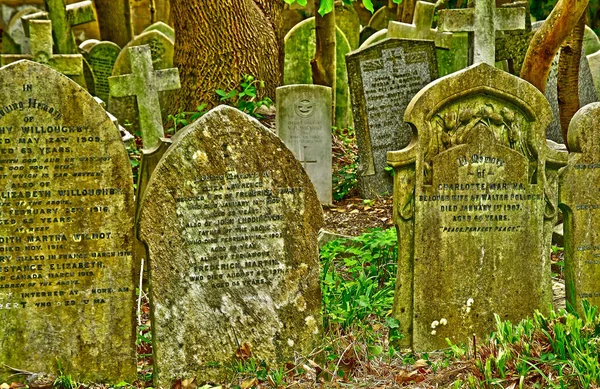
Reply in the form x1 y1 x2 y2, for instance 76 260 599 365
388 64 557 351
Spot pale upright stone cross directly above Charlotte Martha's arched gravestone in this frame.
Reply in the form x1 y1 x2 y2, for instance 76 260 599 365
438 0 525 66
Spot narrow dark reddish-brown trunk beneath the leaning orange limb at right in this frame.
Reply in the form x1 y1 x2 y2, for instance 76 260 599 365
558 12 587 149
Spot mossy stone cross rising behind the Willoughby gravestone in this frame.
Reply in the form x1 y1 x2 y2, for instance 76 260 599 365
0 20 83 76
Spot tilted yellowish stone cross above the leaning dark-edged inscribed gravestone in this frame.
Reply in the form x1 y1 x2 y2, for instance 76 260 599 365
388 1 452 49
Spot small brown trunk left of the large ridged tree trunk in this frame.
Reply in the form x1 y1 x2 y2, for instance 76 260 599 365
94 0 133 47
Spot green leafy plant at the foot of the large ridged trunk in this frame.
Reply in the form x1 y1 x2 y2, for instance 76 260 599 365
215 74 273 119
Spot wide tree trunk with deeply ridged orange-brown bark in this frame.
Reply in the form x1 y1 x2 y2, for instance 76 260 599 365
167 0 284 113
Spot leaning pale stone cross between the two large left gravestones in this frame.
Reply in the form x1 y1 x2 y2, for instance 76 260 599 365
108 45 181 149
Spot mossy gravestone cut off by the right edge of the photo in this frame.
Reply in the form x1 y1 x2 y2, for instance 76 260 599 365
559 103 600 313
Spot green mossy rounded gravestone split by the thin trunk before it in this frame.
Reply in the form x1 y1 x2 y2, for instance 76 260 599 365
283 17 352 128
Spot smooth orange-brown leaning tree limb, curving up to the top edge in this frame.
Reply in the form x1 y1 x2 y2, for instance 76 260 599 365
521 0 588 93
